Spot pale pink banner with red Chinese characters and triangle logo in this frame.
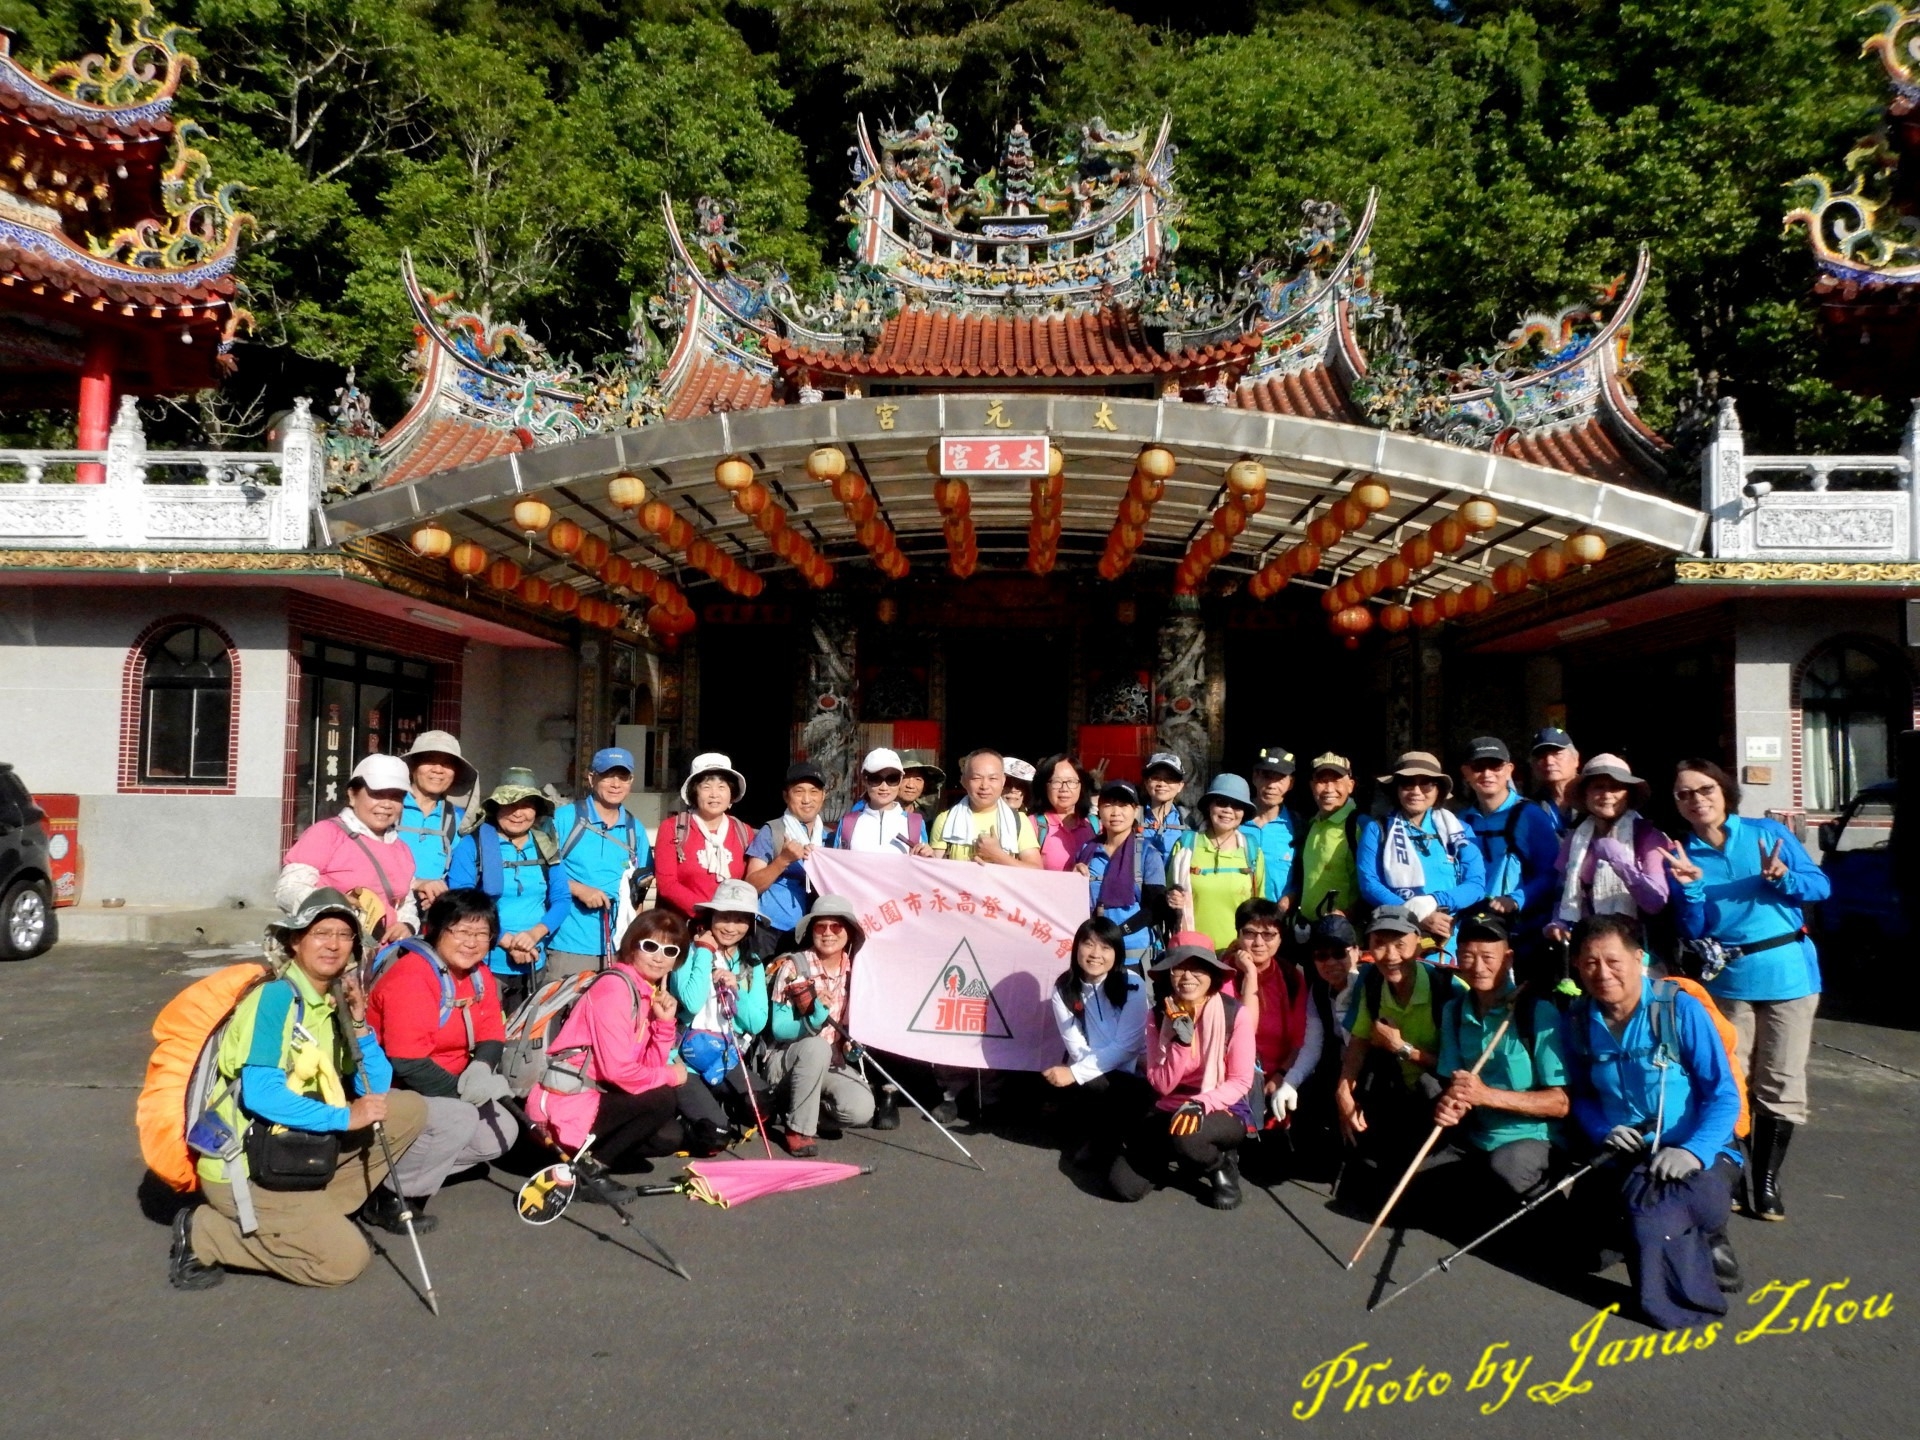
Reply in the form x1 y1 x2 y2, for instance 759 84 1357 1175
806 851 1087 1069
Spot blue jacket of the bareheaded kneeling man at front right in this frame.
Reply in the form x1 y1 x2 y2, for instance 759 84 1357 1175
1561 977 1740 1165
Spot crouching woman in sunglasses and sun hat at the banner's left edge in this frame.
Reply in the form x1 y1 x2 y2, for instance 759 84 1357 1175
756 895 883 1156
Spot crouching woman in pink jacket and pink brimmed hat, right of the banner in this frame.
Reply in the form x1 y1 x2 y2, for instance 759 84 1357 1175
1108 945 1256 1210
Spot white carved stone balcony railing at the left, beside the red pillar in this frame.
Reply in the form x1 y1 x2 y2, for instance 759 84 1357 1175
0 396 324 551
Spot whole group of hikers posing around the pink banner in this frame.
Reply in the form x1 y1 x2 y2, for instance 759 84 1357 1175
169 728 1826 1329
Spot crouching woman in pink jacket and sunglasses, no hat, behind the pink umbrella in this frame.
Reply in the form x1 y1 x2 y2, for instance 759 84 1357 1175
526 910 687 1202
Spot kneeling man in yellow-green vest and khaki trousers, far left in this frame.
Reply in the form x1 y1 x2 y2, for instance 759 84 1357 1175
167 889 426 1290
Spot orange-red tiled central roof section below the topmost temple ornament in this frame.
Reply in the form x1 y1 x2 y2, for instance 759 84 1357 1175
766 305 1260 378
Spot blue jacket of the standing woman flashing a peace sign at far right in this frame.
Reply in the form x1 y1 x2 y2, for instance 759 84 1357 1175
1674 814 1834 1000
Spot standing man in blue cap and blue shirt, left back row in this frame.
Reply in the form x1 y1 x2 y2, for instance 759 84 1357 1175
547 745 653 975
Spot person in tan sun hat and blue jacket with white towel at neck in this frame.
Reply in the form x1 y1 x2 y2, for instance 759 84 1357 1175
1354 751 1486 954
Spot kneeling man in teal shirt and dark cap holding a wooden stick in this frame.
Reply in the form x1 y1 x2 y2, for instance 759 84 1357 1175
1428 914 1567 1212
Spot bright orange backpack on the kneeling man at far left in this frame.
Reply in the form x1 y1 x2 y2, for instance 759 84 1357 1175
134 960 276 1194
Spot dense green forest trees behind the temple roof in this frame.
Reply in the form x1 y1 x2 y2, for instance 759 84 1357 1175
0 0 1905 474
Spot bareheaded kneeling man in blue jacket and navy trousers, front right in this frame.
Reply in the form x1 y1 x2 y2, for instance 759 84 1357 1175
1561 916 1740 1331
